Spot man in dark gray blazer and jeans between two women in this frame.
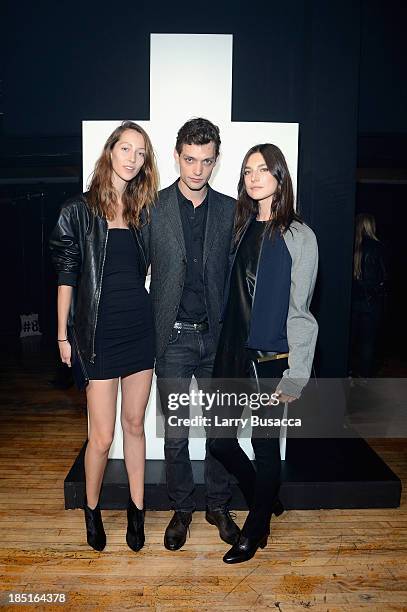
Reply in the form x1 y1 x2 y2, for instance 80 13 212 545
144 118 239 550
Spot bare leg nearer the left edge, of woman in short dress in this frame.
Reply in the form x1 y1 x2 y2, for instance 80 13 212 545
85 378 119 508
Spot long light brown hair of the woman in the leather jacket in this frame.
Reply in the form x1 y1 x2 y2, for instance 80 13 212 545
86 121 158 227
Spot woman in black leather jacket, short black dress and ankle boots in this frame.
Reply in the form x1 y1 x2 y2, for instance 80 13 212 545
50 121 158 551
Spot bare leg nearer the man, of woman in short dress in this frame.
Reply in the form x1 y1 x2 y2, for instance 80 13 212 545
121 370 153 510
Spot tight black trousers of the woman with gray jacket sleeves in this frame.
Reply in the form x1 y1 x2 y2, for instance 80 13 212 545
210 359 288 538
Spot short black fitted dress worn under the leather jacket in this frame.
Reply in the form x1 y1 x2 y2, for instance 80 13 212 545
87 228 155 380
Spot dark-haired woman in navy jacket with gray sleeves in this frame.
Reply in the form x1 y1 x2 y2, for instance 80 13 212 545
211 143 318 563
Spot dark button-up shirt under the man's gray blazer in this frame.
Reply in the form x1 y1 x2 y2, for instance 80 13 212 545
177 186 208 323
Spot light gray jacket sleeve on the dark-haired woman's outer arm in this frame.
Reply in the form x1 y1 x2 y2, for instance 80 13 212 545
278 224 318 398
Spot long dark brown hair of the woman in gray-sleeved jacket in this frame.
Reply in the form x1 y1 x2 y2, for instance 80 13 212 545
235 143 302 242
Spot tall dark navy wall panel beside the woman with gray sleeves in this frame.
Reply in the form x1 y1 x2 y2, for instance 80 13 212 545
299 0 360 376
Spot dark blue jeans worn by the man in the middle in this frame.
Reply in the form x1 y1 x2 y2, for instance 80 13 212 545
155 329 231 512
